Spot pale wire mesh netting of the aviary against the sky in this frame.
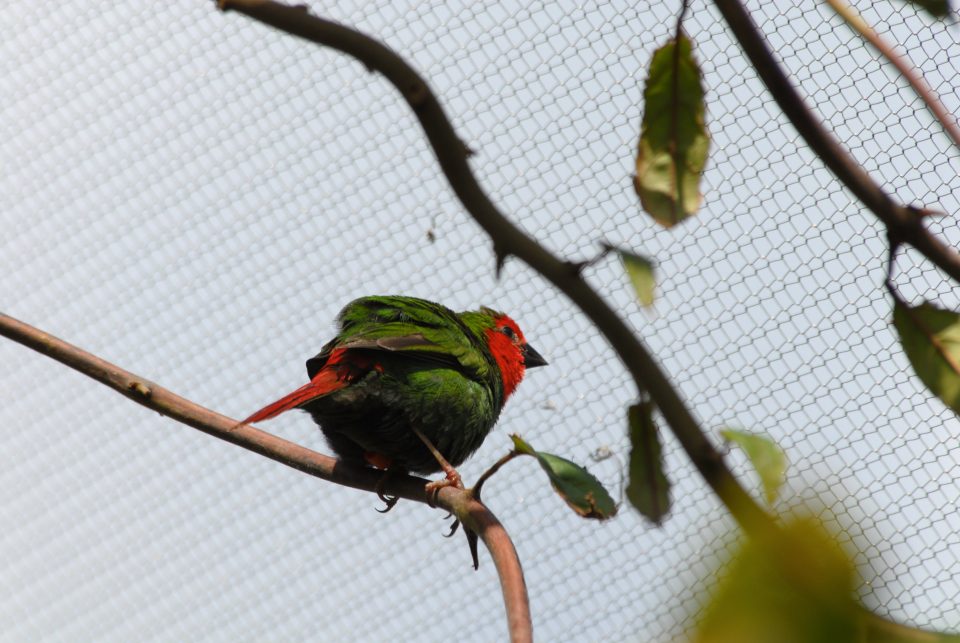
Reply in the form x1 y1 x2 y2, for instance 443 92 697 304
0 0 960 641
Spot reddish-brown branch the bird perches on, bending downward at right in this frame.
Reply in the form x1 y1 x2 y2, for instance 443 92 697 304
0 313 533 643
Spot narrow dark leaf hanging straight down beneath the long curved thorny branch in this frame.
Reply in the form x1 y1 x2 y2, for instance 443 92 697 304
627 402 670 525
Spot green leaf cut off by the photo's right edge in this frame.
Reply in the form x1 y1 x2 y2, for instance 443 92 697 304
893 302 960 413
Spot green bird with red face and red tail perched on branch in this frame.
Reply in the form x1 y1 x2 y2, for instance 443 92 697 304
243 296 547 511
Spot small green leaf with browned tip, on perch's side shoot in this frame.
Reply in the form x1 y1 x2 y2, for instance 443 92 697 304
510 434 617 520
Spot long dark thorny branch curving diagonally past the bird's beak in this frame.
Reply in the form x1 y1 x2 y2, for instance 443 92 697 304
220 0 772 533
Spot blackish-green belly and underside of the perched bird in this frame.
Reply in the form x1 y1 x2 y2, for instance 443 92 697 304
304 368 497 474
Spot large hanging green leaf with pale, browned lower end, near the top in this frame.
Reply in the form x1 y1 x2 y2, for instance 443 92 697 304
633 36 710 227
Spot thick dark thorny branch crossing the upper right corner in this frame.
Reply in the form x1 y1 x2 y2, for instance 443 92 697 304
713 0 960 283
